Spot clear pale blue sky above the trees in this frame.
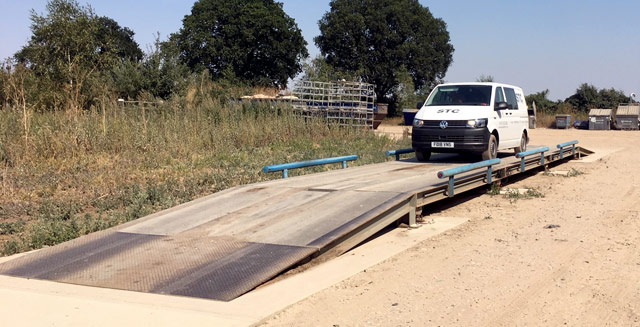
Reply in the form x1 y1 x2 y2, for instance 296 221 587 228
0 0 640 100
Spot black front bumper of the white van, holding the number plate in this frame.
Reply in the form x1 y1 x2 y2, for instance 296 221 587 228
411 127 491 153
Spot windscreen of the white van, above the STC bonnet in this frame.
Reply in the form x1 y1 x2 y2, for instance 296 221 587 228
426 85 491 106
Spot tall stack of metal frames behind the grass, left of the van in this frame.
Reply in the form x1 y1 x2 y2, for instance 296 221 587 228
292 81 375 128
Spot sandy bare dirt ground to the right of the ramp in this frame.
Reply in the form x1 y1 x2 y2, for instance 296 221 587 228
261 127 640 327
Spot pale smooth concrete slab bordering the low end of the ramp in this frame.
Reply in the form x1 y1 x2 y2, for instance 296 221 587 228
0 217 466 327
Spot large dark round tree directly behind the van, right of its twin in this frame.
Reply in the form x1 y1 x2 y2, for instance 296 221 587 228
315 0 454 113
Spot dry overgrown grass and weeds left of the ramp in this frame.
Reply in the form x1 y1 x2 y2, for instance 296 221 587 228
0 98 407 255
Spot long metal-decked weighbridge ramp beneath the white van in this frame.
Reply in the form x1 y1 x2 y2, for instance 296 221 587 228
0 147 590 301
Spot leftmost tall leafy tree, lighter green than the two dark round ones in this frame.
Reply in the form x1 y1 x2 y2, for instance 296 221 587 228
15 0 141 112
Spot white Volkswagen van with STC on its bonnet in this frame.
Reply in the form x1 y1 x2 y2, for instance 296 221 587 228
411 83 529 161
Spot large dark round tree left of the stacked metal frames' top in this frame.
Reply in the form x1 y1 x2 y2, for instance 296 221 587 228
172 0 308 87
